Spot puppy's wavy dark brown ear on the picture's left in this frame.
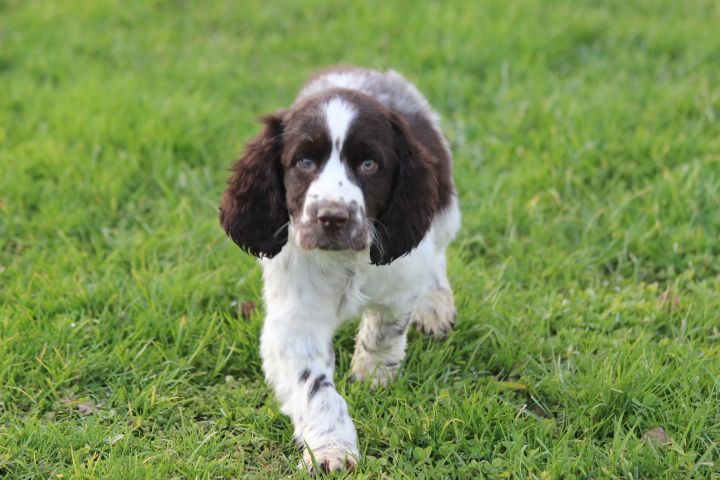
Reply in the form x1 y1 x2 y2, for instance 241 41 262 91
220 112 290 258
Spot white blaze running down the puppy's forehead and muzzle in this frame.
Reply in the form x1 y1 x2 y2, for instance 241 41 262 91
303 98 365 221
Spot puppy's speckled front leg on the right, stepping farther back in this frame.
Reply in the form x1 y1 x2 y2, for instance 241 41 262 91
352 310 410 386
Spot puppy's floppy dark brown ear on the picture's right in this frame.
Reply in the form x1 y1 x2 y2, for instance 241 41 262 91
370 113 438 265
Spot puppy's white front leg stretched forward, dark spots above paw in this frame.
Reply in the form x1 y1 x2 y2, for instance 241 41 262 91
261 312 359 471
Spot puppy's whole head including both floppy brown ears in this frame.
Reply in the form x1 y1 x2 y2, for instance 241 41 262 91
220 90 438 265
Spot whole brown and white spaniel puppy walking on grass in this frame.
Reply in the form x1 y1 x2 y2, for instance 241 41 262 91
220 68 460 471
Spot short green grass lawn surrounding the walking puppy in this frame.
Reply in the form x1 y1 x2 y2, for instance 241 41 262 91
0 0 720 479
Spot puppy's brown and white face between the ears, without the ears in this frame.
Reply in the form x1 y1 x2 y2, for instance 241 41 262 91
282 92 396 250
